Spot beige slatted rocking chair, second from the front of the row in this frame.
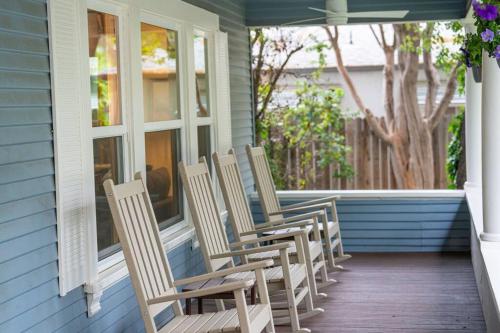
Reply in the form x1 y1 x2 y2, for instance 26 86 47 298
179 158 324 332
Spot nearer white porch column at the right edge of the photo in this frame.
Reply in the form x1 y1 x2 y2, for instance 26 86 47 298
481 54 500 242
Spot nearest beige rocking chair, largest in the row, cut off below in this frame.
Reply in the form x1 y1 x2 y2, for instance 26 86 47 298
104 175 274 333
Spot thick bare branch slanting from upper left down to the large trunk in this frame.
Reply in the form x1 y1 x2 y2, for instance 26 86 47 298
324 26 392 144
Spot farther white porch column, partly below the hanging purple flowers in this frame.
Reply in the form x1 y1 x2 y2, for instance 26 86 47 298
465 24 482 188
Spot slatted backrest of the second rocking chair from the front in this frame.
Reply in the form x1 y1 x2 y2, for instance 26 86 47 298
179 158 233 271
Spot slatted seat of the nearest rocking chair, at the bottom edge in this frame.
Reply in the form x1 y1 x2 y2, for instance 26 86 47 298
158 304 269 333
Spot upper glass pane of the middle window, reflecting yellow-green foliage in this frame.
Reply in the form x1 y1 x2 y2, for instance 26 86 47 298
141 23 180 122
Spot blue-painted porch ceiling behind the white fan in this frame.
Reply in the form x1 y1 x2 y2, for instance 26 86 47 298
245 0 470 27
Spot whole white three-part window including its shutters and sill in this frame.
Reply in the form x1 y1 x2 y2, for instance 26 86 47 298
49 0 231 296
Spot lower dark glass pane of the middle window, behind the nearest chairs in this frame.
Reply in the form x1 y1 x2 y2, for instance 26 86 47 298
146 130 182 228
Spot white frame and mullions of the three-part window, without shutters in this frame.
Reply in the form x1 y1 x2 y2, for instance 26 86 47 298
83 0 218 276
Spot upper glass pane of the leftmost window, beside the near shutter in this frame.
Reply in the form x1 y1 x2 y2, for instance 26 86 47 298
87 10 122 127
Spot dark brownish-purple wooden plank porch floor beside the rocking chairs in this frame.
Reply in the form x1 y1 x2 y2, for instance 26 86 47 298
277 253 486 333
